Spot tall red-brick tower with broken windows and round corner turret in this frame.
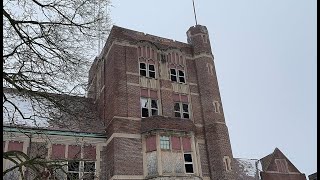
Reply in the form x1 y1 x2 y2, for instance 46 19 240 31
88 25 235 180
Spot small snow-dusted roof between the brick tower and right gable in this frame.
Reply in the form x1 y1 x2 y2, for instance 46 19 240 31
234 158 261 180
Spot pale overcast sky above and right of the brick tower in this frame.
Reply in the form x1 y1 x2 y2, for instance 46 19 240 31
110 0 317 176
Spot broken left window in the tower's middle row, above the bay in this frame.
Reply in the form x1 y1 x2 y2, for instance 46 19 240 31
140 97 159 118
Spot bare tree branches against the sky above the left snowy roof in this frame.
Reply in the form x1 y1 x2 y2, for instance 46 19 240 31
3 0 110 110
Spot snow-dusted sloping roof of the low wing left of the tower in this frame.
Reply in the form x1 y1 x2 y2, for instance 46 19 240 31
3 88 105 133
